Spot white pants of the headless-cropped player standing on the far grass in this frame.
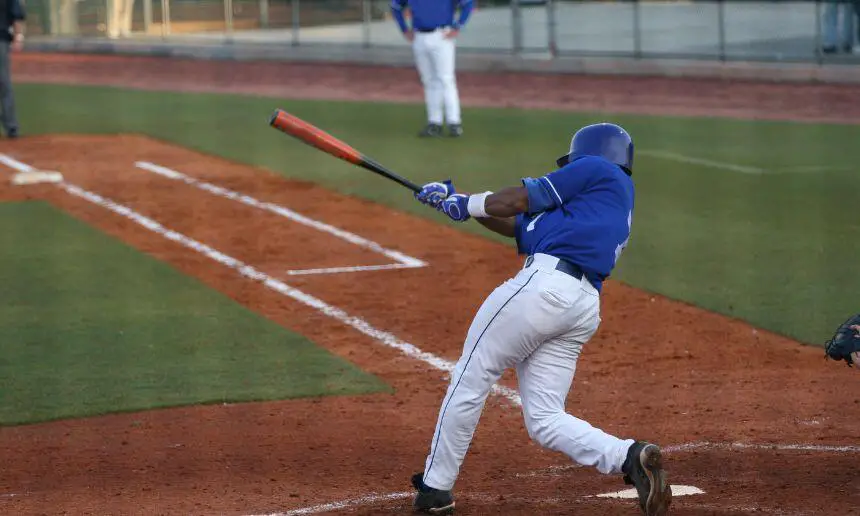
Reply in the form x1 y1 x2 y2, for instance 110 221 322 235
412 29 461 125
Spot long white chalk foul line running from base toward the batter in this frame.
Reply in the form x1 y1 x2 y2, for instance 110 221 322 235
0 154 522 406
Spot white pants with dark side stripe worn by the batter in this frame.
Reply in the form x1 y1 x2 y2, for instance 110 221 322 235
424 254 634 490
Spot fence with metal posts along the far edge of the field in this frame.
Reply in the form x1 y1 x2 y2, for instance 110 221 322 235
28 0 860 64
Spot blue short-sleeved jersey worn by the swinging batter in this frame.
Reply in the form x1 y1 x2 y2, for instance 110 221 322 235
515 156 634 291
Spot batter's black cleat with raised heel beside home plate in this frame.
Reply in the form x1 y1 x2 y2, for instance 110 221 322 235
621 441 672 516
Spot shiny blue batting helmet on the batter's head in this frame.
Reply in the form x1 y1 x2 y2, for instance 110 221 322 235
556 123 633 174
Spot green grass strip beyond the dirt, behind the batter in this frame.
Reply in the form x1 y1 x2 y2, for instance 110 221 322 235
11 85 860 343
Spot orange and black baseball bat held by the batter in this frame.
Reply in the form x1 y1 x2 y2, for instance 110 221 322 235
269 109 421 192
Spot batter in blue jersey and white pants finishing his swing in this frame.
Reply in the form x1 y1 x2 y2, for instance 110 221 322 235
412 123 672 516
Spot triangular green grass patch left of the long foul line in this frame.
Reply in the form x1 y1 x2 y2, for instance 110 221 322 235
0 202 388 425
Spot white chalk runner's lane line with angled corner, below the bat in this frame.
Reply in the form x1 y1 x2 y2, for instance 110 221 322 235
134 161 428 276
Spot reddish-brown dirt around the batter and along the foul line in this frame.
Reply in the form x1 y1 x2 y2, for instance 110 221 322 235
0 136 860 515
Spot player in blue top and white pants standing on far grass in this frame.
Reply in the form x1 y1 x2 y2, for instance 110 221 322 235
391 0 472 137
